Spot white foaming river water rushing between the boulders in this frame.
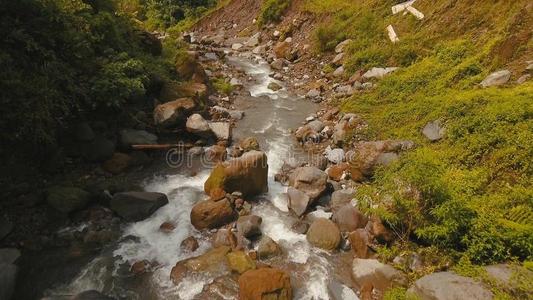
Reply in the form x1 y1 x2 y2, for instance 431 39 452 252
43 54 352 299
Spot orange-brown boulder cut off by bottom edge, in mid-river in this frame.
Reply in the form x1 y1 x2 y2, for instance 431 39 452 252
239 268 292 300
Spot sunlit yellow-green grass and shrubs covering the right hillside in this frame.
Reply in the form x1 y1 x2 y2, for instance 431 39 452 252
306 0 533 274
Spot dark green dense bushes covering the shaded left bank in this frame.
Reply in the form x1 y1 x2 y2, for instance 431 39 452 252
0 0 215 169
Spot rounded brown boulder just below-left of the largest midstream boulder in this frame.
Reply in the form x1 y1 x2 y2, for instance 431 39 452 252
191 199 236 230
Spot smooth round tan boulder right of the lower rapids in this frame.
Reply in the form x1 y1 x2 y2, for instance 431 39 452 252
307 218 341 250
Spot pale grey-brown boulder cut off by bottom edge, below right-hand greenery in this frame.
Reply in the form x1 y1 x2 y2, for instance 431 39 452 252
407 272 494 300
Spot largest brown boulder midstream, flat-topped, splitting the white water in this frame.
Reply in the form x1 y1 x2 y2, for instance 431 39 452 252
204 150 268 196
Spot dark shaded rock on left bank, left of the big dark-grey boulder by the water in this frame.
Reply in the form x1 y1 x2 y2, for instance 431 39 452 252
46 186 90 213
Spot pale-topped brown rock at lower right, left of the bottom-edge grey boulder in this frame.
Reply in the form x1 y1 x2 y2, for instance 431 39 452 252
352 258 406 292
